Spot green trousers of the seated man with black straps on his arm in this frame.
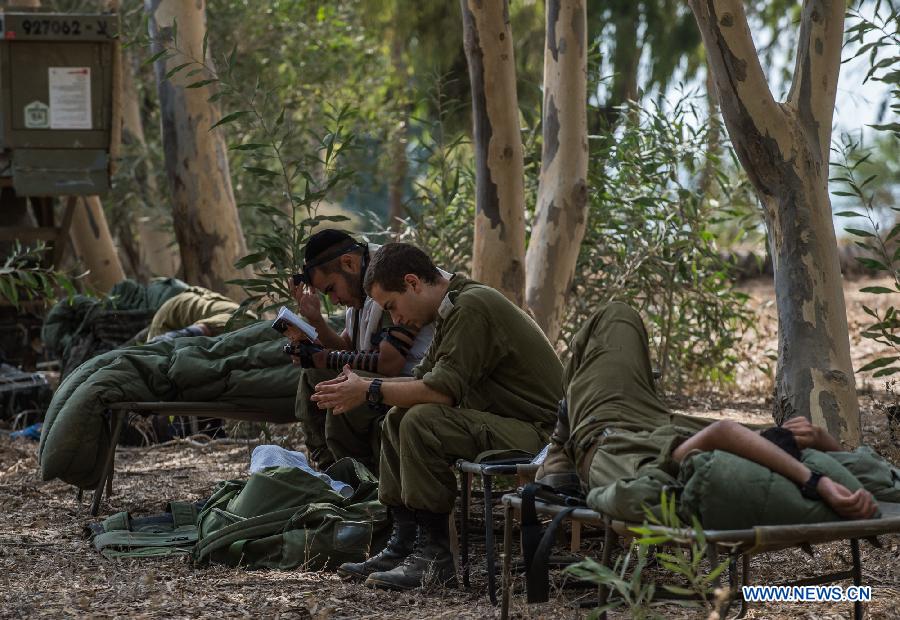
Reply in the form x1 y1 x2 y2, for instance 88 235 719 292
295 368 384 475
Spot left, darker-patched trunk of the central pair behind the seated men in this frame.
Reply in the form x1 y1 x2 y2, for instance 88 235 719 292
461 0 525 306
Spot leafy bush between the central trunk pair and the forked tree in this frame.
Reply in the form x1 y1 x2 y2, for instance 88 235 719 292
563 97 750 390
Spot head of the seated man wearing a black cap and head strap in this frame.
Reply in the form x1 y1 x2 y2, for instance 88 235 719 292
294 228 369 308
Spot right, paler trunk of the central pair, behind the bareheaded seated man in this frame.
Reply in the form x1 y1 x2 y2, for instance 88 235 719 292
525 0 588 342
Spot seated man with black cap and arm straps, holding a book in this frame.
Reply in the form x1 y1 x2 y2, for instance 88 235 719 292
293 229 442 473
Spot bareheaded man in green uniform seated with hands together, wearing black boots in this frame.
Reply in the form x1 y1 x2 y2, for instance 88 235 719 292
313 243 563 589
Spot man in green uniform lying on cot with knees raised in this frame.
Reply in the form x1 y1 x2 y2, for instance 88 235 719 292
536 302 876 522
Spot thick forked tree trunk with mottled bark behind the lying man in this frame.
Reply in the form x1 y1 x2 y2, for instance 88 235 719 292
689 0 860 445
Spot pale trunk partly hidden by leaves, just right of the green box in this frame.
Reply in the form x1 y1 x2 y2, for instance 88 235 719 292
121 52 178 276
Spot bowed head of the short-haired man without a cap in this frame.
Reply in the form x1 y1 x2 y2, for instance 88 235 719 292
363 243 448 328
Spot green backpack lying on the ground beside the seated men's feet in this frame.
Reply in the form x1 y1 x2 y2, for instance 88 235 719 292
193 458 391 570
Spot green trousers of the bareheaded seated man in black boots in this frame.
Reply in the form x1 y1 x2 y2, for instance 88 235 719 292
378 404 549 513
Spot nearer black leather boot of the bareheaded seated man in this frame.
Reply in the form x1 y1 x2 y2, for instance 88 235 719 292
366 510 456 590
